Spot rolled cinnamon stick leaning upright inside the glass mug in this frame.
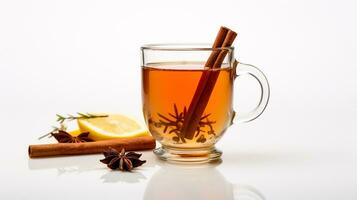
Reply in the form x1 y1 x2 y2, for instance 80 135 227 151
181 26 237 140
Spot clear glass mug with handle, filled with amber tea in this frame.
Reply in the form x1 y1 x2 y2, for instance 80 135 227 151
141 44 270 162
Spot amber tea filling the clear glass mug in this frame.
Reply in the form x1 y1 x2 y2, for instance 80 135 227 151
142 64 233 148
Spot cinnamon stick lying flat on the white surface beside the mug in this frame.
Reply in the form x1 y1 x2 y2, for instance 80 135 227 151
28 136 156 158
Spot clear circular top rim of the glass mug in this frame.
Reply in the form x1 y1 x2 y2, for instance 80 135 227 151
140 43 234 51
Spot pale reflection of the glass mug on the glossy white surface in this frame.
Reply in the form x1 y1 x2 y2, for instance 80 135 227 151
144 164 265 200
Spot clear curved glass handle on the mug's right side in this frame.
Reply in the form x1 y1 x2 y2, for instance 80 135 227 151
232 60 270 124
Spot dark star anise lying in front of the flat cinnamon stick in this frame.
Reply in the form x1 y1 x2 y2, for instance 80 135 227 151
100 147 146 171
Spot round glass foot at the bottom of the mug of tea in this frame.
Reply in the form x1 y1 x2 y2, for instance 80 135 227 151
153 146 222 163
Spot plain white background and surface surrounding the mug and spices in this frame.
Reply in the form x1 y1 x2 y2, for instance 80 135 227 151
0 0 357 200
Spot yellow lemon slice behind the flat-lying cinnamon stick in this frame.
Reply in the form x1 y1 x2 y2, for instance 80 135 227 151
77 114 150 141
